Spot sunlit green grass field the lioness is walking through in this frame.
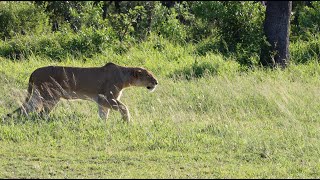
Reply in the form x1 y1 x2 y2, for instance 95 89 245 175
0 44 320 178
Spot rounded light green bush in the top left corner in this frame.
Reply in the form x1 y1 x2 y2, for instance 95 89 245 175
0 1 49 39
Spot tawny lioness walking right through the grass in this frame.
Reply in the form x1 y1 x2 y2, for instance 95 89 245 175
7 63 158 122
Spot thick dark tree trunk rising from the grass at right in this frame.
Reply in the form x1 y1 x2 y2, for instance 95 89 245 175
260 1 292 68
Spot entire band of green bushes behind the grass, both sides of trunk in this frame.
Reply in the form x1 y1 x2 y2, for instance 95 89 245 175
0 1 320 68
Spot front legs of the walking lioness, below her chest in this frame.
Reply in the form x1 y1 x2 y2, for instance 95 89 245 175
98 95 130 122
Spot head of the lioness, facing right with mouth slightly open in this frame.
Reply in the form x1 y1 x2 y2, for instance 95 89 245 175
132 68 158 92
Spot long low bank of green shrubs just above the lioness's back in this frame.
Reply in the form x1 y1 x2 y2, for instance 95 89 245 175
0 28 114 60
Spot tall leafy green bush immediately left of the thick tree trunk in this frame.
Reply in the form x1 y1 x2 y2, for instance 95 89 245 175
192 1 265 66
